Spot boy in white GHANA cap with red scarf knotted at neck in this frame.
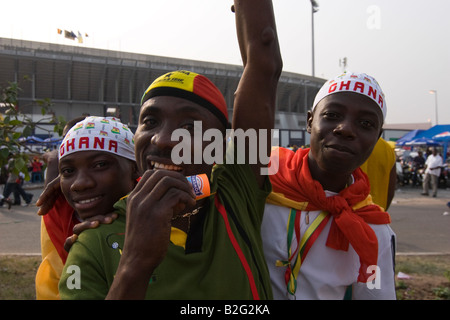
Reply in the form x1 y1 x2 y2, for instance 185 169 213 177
262 73 395 299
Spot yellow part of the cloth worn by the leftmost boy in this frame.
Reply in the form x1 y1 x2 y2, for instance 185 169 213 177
36 219 64 300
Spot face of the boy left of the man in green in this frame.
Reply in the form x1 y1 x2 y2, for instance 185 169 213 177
59 151 137 219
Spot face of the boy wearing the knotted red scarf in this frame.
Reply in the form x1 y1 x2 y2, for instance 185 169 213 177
308 92 383 179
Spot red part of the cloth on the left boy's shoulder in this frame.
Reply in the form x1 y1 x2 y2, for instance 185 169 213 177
43 195 79 264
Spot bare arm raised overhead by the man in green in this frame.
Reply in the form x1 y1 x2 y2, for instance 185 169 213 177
232 0 283 186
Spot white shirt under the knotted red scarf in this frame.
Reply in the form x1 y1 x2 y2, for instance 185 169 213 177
261 192 396 300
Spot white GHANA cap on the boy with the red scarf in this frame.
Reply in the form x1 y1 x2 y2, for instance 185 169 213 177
312 71 387 120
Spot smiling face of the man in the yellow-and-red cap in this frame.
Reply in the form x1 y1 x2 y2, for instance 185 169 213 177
134 96 225 177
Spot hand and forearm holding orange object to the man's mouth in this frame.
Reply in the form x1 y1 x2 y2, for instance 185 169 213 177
106 170 196 300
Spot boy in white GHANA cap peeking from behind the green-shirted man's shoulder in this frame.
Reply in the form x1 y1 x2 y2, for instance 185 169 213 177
36 116 139 299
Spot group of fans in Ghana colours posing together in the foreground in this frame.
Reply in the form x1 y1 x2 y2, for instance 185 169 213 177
1 0 406 300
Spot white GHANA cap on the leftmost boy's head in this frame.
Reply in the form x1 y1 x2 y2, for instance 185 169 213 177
58 116 135 161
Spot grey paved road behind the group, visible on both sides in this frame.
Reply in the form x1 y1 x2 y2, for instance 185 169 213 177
0 184 450 254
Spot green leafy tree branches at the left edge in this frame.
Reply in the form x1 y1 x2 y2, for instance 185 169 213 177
0 77 66 180
